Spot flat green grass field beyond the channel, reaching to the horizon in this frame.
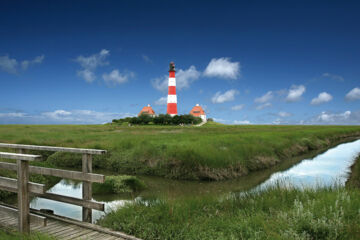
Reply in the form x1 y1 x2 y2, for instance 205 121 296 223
0 123 360 180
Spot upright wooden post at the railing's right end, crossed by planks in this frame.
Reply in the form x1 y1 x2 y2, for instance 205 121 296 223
82 153 92 223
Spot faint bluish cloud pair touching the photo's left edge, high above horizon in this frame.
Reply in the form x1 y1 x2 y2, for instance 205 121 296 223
0 55 45 74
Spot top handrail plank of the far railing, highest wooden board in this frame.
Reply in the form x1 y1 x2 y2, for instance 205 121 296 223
0 143 106 155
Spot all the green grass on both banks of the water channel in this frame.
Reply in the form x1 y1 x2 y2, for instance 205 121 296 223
0 123 360 239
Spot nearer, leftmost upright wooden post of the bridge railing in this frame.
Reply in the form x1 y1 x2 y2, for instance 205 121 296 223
17 149 30 234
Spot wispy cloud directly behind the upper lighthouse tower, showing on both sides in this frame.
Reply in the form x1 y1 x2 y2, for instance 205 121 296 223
151 66 201 92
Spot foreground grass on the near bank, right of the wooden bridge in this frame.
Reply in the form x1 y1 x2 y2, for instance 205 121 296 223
99 186 360 239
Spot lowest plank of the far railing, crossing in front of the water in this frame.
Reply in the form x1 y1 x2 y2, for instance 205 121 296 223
36 193 105 211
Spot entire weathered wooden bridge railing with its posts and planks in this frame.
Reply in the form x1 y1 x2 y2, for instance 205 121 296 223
0 143 106 233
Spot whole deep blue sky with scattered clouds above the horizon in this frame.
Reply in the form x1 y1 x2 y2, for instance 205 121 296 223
0 1 360 124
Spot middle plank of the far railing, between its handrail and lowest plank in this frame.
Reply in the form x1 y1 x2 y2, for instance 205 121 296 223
0 162 105 183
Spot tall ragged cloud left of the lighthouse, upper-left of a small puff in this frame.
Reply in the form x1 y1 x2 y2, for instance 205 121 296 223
75 49 110 83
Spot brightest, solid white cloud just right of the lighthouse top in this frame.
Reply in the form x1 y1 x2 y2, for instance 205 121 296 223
204 57 241 79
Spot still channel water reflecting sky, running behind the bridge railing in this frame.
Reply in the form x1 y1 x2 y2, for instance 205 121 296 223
30 140 360 222
